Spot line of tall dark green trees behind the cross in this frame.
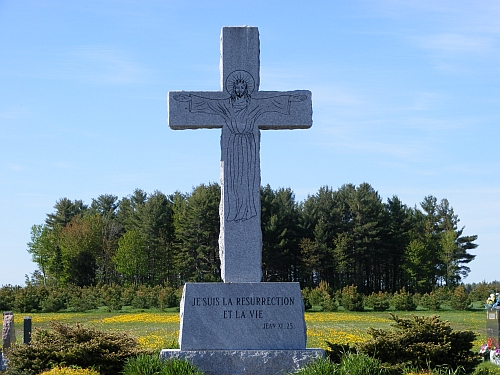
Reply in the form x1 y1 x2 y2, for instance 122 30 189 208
28 183 477 294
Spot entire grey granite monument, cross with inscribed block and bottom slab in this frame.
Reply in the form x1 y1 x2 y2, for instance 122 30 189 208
161 26 323 375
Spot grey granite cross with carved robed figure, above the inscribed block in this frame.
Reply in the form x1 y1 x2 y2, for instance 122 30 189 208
168 26 312 283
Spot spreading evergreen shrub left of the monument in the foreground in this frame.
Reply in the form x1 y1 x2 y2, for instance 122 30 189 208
8 322 145 375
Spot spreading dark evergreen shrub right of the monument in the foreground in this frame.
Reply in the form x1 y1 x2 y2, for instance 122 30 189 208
357 314 480 373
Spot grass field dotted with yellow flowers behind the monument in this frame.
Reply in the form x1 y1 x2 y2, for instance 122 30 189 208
8 310 486 350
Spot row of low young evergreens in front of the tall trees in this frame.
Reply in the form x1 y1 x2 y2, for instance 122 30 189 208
0 282 489 313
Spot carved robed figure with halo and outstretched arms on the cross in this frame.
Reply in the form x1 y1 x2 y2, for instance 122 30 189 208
174 70 307 221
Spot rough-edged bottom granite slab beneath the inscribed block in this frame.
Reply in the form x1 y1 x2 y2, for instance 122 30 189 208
160 349 325 375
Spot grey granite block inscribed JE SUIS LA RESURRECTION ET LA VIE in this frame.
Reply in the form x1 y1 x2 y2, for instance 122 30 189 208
179 283 306 350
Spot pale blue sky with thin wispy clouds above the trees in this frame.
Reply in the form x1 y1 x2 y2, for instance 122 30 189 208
0 0 500 285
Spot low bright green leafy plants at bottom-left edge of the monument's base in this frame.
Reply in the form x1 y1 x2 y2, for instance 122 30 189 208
123 354 202 375
